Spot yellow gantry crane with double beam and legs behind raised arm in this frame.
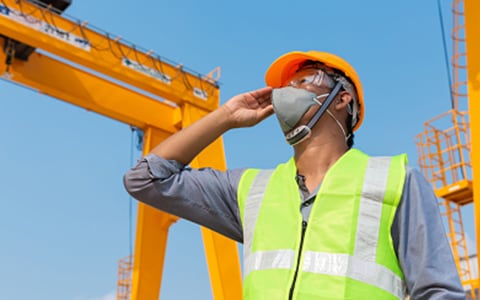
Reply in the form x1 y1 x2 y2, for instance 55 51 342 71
0 0 242 300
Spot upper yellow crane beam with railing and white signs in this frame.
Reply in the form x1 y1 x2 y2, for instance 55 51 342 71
0 0 219 110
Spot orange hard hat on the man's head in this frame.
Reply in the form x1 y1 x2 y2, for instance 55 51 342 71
265 51 365 131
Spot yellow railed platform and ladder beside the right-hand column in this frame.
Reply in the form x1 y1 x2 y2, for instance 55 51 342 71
415 109 473 290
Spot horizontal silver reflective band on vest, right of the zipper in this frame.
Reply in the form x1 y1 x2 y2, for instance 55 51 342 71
303 251 405 299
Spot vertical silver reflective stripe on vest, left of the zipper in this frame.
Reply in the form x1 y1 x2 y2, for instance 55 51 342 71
243 170 274 277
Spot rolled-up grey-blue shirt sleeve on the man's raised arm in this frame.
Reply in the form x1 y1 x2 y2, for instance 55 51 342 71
123 154 244 242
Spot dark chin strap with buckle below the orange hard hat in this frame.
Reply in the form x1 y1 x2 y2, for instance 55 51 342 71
285 81 348 146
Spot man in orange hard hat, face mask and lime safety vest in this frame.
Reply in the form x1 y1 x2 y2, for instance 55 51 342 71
124 51 465 299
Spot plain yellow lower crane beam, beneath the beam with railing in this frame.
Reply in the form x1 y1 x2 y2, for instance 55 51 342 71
0 41 181 134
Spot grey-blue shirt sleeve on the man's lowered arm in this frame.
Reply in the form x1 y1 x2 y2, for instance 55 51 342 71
392 167 465 300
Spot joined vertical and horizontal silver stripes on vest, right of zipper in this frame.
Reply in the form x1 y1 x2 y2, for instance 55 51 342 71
303 157 405 299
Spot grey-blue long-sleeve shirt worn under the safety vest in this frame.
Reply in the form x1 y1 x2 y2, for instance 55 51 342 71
124 154 465 300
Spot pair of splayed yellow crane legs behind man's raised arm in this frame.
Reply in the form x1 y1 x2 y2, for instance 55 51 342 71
131 109 242 300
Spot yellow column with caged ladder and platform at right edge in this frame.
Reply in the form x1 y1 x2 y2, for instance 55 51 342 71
415 0 480 299
